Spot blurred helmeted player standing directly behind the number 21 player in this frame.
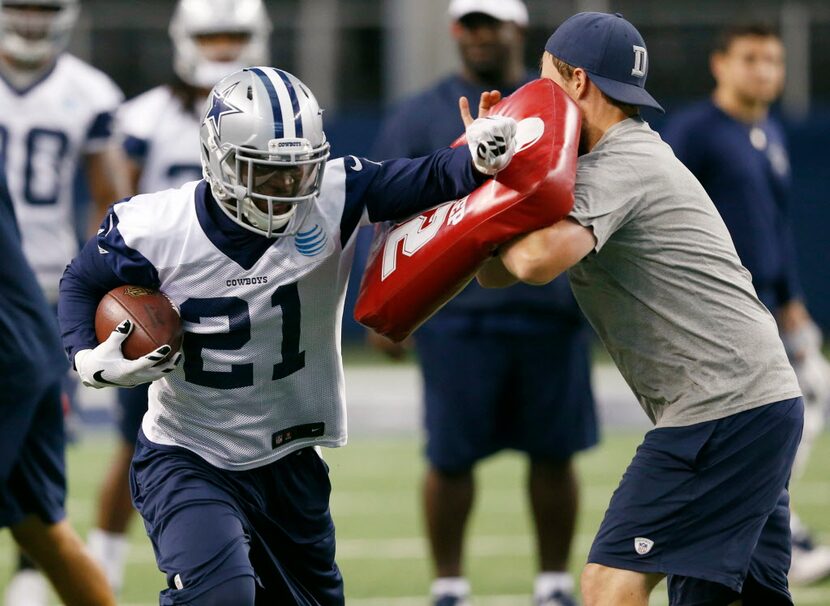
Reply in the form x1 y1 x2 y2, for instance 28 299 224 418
88 0 271 592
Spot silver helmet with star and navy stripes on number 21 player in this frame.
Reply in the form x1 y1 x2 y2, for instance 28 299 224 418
199 67 329 238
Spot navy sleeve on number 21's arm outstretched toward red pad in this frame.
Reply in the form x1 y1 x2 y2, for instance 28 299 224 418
341 147 489 242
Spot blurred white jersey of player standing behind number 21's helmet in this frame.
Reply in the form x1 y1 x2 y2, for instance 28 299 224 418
116 86 202 192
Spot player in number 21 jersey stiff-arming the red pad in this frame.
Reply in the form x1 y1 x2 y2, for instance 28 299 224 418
60 67 516 606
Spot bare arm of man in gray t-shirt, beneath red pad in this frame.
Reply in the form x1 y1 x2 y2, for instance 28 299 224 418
477 218 596 288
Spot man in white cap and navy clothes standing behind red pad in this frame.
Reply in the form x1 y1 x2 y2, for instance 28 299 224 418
372 0 597 606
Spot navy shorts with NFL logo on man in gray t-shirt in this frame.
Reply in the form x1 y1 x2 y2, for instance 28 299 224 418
588 398 804 606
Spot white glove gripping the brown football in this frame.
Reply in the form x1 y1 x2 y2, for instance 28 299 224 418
75 320 182 389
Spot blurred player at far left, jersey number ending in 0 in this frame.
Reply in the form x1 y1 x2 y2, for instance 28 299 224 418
0 0 128 604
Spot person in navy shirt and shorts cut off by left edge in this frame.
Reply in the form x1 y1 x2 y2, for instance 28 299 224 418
0 167 115 606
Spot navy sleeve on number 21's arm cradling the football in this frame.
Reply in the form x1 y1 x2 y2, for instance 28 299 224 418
58 208 159 362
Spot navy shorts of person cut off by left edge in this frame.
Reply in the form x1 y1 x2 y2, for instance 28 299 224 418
0 379 66 527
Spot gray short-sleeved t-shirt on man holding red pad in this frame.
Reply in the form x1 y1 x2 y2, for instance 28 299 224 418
568 118 801 427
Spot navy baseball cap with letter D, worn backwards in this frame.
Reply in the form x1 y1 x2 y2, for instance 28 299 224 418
545 13 664 112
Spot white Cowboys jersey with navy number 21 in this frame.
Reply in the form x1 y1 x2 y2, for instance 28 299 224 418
113 159 368 476
